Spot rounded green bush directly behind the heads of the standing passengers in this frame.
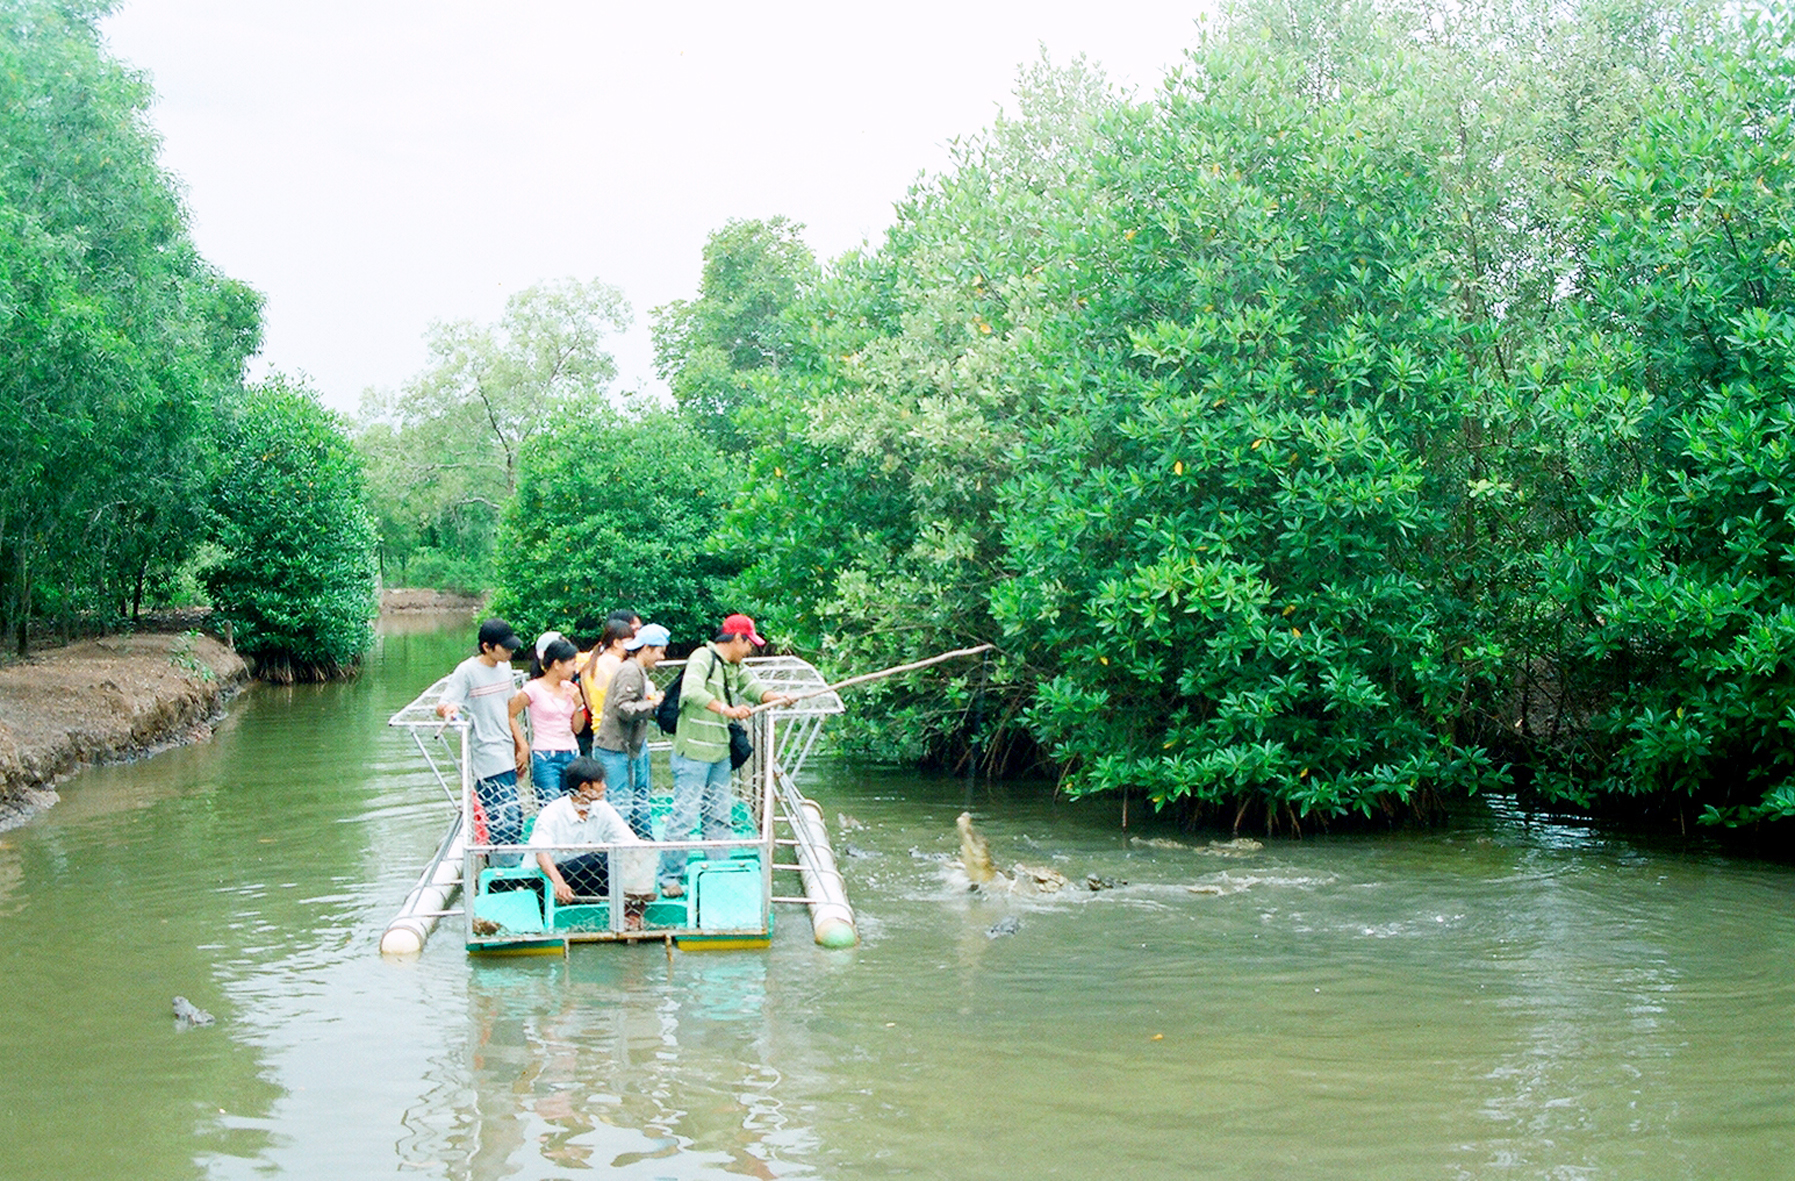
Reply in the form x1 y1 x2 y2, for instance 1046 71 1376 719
494 406 736 644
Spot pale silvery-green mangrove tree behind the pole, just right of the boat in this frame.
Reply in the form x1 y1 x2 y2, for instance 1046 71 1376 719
710 63 1118 766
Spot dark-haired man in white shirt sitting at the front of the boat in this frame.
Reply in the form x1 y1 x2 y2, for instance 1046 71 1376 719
530 757 653 930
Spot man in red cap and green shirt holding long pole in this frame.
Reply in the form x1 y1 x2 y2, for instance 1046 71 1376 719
661 616 792 886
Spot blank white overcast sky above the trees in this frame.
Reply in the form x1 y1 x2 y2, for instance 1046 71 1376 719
104 0 1206 411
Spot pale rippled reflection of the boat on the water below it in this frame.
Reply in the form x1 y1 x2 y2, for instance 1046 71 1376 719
418 946 792 1177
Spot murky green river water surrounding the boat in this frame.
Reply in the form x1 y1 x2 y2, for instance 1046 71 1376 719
0 630 1795 1179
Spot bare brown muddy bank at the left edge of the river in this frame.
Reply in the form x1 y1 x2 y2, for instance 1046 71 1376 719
0 632 250 829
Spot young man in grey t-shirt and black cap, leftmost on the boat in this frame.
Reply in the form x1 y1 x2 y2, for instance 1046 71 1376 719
436 619 530 865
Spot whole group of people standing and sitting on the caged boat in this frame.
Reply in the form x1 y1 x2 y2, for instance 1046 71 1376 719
436 610 790 924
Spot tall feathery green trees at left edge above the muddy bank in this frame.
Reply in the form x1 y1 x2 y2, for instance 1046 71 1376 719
0 0 260 648
